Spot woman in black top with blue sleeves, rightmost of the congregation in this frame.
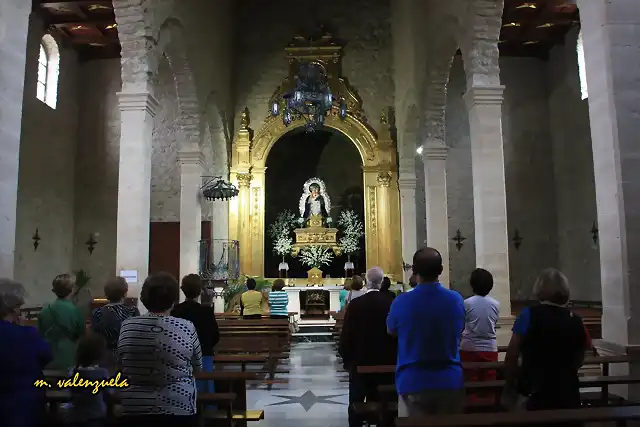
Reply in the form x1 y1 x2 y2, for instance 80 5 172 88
505 268 590 420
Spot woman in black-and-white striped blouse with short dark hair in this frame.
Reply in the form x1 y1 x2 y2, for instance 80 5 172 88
117 273 202 427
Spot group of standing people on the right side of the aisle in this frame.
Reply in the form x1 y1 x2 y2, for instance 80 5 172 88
339 247 591 427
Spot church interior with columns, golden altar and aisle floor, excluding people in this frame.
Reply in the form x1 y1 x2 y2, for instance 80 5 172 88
0 0 640 427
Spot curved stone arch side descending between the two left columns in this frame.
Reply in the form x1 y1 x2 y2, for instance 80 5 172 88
158 18 202 149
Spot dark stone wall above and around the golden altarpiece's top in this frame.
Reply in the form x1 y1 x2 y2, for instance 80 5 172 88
236 0 393 135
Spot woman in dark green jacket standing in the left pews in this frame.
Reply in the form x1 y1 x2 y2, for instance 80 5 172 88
38 274 85 369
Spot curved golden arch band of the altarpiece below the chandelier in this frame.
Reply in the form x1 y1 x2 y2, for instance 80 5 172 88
251 112 382 168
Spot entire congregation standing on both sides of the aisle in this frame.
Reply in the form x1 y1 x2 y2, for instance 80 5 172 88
0 248 591 427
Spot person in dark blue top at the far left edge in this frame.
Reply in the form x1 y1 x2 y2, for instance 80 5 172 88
0 279 53 427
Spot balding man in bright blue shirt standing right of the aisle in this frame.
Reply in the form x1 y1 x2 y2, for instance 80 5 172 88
387 248 465 417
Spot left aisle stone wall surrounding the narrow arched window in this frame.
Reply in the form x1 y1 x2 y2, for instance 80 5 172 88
14 16 78 304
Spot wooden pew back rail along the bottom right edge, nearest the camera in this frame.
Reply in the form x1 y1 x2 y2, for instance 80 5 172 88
396 406 640 427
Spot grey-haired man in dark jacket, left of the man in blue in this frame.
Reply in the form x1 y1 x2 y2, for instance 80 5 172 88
339 267 397 427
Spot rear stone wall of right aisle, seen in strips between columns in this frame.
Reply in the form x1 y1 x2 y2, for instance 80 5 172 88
416 56 557 299
